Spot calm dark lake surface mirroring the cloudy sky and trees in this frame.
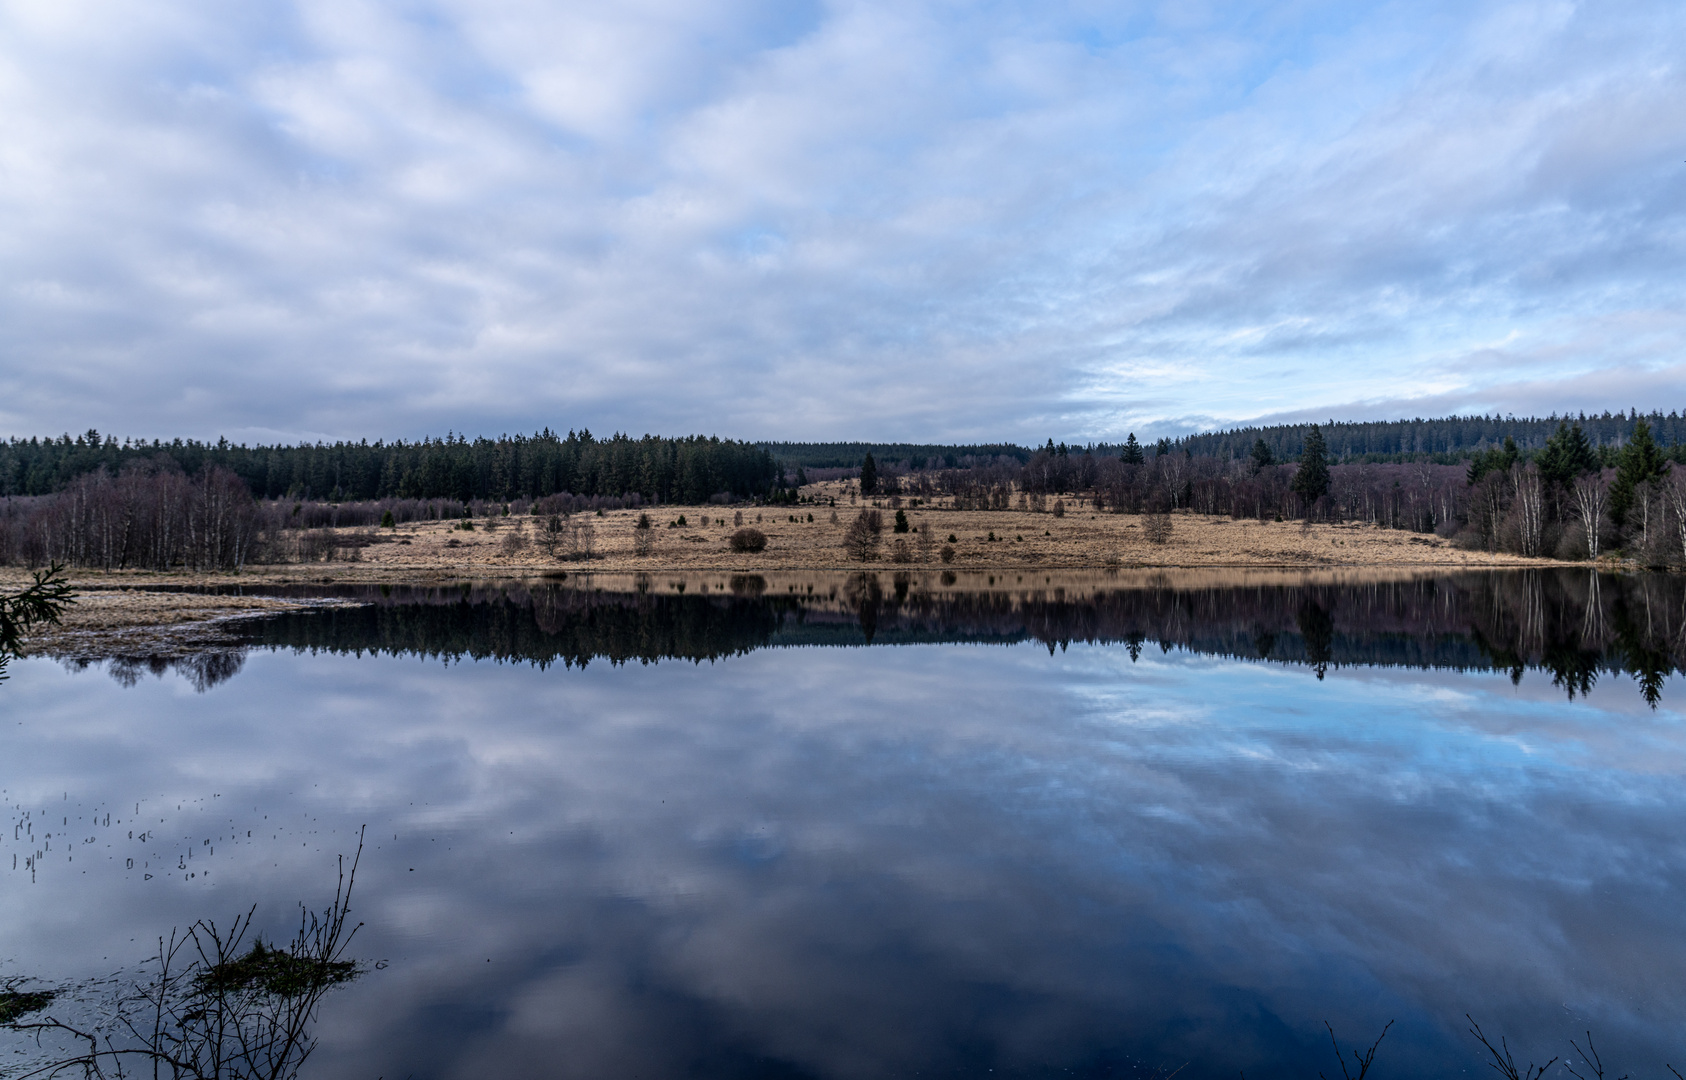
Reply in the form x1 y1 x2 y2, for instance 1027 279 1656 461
0 571 1686 1077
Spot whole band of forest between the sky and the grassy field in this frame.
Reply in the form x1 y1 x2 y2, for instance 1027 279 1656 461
0 413 1686 569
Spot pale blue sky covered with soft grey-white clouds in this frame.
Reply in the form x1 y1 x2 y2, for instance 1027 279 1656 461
0 0 1686 441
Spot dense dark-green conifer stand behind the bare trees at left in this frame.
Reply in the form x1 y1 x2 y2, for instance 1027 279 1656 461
0 430 786 504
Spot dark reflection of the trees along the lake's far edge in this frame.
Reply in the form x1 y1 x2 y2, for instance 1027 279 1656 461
59 569 1686 706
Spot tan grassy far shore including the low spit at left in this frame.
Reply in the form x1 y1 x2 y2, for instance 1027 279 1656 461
0 507 1629 659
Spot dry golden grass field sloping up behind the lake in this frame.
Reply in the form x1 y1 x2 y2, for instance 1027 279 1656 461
0 485 1551 585
